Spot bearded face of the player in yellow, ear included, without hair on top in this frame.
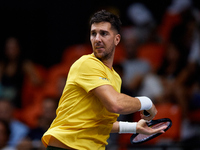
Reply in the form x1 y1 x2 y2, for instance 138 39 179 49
90 22 120 61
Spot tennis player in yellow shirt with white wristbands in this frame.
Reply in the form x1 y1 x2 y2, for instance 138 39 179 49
42 10 164 150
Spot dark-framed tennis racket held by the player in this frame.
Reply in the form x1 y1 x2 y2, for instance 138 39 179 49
130 111 172 144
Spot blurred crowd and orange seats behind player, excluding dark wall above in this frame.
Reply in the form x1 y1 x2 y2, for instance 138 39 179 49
0 0 200 150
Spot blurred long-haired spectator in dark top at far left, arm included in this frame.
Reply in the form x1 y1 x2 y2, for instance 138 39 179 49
0 37 44 108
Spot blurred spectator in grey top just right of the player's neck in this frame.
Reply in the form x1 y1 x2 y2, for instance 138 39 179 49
121 27 151 96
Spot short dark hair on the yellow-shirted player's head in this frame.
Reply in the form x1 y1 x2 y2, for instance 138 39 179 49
90 10 122 33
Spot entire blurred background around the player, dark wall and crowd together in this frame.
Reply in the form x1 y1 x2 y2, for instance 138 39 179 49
0 0 200 150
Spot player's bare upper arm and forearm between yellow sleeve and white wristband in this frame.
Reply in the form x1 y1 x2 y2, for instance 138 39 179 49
92 85 141 114
